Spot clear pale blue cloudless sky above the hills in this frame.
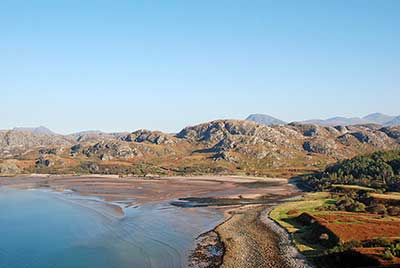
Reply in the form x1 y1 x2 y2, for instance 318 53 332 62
0 0 400 133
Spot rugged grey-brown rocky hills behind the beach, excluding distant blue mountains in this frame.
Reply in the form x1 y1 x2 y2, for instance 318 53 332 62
0 120 400 176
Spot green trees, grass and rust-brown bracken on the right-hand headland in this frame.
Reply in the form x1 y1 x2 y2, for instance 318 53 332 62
271 151 400 268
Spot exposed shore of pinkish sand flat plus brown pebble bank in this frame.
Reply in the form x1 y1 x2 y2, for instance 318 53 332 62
0 175 302 268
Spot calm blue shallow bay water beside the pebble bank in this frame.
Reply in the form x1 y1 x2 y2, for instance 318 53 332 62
0 188 223 268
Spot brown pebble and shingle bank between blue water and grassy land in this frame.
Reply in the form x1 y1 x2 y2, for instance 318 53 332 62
189 205 313 268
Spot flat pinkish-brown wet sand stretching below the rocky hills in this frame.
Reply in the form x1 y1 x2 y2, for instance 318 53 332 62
0 175 297 205
